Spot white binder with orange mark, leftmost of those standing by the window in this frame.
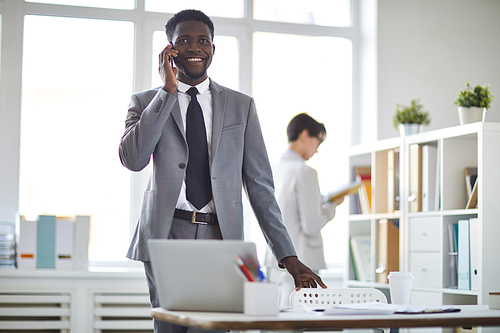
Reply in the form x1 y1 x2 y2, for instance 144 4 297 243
17 216 38 269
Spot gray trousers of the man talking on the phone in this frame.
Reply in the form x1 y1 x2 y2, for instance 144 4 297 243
144 218 226 333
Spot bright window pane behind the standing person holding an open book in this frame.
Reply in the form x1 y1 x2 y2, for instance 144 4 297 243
252 32 352 262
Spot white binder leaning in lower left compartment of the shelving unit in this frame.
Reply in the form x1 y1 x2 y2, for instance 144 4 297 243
350 234 371 281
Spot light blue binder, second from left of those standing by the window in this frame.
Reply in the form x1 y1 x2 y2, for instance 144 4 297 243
36 215 56 268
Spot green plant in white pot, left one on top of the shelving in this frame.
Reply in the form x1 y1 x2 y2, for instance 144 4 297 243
392 98 431 136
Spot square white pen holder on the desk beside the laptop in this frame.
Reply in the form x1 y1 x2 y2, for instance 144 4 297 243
243 282 279 316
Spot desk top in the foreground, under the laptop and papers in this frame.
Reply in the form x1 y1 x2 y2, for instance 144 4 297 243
151 305 500 330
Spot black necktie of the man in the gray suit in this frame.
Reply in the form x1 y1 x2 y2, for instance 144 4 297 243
186 87 212 209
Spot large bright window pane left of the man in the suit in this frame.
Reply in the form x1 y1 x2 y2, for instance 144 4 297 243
19 15 134 261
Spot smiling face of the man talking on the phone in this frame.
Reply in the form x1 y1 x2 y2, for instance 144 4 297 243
172 21 215 86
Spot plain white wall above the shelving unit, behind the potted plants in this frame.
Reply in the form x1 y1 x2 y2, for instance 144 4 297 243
377 0 500 139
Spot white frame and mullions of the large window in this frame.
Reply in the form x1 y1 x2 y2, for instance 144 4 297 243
0 0 368 265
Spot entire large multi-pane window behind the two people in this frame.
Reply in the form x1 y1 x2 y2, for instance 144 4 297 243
0 0 359 265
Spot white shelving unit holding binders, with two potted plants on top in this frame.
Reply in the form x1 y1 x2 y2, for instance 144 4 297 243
345 122 500 332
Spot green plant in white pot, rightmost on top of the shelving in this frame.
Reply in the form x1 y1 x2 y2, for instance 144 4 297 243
453 81 494 125
